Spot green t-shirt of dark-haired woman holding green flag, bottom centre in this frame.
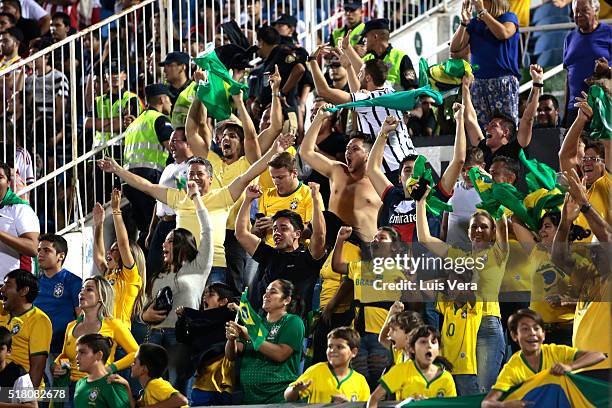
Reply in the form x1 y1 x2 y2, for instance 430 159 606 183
240 314 304 404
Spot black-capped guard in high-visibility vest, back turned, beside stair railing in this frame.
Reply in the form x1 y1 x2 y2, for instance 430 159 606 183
123 84 173 242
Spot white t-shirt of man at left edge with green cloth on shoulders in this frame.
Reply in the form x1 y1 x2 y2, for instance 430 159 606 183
0 204 40 281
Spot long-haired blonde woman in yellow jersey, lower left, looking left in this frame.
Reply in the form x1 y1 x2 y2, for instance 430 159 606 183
51 276 138 398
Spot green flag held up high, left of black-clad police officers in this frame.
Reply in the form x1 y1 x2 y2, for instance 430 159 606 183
194 43 249 120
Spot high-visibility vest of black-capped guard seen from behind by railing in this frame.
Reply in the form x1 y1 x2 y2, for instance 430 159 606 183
123 109 168 172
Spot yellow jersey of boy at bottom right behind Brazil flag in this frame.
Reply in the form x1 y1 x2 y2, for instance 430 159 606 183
493 344 578 392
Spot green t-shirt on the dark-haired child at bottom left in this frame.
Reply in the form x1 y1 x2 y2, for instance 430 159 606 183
74 374 130 408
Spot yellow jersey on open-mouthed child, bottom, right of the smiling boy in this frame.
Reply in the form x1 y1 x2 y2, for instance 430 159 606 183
378 360 457 400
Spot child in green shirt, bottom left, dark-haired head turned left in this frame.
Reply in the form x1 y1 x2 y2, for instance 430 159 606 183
74 333 130 408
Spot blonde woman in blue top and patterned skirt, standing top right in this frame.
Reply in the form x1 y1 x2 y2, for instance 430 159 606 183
451 0 521 128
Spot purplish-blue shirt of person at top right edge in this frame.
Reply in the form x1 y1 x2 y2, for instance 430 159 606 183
563 23 612 110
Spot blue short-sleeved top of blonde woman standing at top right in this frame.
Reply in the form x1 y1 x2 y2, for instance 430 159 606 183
467 12 521 79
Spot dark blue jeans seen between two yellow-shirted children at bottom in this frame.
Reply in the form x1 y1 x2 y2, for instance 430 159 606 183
352 333 392 390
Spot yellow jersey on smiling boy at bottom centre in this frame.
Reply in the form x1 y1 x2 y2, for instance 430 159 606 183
291 362 370 404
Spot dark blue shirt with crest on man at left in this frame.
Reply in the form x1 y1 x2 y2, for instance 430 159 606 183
34 269 83 353
